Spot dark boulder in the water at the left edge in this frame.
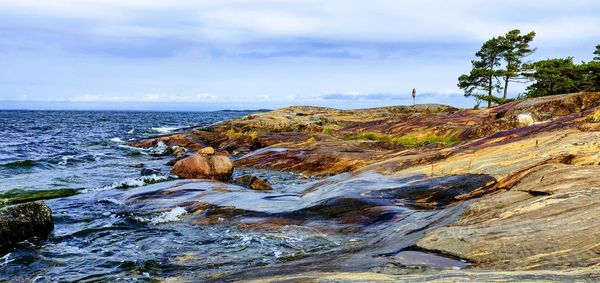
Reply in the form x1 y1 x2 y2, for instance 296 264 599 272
0 201 54 253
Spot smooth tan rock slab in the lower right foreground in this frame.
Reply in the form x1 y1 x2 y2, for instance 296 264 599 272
417 164 600 269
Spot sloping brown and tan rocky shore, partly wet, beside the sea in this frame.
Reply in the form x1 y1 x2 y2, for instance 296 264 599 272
130 93 600 281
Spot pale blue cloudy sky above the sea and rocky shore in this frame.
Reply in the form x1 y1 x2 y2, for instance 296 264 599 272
0 0 600 111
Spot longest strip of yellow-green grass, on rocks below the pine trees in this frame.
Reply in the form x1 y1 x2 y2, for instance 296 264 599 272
346 132 460 147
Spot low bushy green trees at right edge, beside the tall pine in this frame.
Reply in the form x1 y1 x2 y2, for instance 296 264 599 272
525 57 600 97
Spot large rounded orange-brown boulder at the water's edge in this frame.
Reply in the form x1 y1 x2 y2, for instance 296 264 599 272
171 154 233 181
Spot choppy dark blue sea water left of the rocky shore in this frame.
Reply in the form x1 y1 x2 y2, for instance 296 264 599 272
0 111 336 282
